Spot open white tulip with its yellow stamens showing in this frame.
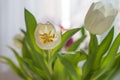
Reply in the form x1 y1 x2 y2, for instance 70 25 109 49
35 22 61 50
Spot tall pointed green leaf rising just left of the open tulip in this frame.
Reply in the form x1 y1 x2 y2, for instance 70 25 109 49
25 9 44 54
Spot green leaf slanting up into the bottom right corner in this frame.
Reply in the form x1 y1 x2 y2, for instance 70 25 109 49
91 54 120 80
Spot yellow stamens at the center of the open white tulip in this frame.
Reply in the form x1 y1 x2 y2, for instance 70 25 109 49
40 31 55 44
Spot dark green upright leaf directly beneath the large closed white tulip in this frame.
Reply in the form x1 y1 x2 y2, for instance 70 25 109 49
83 34 98 80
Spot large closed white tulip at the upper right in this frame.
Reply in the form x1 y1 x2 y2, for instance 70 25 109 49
85 2 117 34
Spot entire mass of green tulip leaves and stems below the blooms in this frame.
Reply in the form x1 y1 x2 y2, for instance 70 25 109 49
0 9 120 80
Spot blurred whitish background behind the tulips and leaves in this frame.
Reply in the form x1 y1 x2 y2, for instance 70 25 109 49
0 0 120 80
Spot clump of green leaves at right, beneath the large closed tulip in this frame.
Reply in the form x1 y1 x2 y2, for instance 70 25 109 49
83 28 120 80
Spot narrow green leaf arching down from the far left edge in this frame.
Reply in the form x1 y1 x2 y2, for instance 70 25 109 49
0 56 27 80
